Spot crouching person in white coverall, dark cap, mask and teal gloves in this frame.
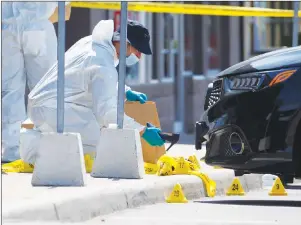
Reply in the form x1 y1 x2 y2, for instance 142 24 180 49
16 20 164 167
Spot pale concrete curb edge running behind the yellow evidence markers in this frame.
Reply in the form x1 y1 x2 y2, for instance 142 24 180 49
2 169 262 222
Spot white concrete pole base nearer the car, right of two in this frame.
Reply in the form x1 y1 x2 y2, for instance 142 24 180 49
91 128 144 179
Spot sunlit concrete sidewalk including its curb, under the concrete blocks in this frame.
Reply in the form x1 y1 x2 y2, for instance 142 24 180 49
2 145 261 222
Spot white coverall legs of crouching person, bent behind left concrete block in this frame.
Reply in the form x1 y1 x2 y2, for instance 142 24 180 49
20 101 100 164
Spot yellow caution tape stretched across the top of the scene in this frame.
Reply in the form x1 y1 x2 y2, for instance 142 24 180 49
71 2 301 17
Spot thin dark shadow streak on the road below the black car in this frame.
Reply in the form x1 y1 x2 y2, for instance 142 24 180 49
194 200 301 207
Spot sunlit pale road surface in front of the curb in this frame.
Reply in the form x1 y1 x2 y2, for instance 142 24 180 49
6 190 301 225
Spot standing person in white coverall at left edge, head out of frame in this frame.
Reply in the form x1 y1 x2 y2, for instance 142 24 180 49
1 1 68 162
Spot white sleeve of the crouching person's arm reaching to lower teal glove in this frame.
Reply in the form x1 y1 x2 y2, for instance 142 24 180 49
91 68 145 132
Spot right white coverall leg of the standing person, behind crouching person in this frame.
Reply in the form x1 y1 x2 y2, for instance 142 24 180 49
23 20 57 91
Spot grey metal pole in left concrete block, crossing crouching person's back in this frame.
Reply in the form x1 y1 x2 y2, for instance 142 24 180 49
57 2 65 133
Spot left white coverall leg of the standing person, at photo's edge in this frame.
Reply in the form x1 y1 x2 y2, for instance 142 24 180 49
1 30 26 162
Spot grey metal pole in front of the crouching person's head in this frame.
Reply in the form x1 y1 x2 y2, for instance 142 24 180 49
117 2 128 129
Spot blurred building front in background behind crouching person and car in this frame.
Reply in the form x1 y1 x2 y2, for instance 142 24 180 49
57 1 298 133
